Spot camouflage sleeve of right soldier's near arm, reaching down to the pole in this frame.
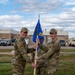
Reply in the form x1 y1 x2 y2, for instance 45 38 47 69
38 43 60 59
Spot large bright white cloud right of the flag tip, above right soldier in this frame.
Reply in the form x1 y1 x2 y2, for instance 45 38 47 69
41 11 75 37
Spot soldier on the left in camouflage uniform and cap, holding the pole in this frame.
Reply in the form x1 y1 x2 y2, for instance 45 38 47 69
13 27 35 75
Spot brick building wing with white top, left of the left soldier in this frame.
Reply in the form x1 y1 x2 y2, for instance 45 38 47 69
0 28 19 40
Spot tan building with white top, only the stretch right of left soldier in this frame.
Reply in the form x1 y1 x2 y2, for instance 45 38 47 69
28 30 68 44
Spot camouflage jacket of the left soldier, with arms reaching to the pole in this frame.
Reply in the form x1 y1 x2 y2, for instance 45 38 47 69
14 37 35 62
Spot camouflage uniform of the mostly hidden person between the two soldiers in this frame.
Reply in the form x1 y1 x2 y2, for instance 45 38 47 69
36 49 47 75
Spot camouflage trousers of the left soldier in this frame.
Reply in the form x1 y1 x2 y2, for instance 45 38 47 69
13 60 26 75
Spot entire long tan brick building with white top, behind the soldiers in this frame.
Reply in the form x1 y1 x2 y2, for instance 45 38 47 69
0 29 68 44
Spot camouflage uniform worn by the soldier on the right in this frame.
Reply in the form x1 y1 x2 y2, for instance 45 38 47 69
38 28 60 75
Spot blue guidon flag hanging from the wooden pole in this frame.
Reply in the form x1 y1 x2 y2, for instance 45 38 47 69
32 19 44 44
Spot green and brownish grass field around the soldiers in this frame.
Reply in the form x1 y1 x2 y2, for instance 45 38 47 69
0 49 75 75
